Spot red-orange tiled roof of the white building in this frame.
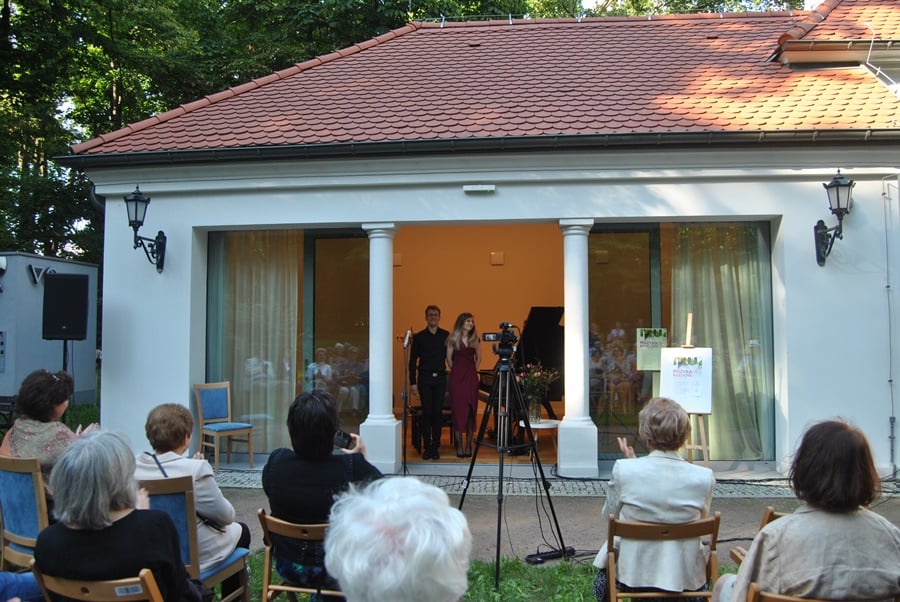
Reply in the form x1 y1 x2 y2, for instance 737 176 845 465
73 0 900 155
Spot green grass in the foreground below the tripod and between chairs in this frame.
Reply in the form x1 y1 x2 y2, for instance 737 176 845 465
244 550 596 602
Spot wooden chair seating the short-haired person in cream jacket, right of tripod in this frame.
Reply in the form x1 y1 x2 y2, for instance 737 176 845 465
607 512 721 602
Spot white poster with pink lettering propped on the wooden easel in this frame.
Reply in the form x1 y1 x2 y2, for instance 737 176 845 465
659 347 712 414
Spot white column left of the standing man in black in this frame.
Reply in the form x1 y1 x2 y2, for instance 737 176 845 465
359 223 401 474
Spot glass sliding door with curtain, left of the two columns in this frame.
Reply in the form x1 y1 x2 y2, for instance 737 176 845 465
207 230 368 453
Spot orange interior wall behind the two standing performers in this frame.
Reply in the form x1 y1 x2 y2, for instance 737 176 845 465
394 224 565 405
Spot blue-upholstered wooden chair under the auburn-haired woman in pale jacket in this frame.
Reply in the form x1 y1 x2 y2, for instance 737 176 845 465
139 477 250 602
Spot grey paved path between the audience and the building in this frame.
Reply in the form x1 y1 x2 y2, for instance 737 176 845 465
217 464 900 565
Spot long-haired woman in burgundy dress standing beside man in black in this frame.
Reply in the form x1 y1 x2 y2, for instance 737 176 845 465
447 313 481 458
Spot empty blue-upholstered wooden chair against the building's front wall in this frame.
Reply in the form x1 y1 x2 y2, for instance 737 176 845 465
194 380 253 472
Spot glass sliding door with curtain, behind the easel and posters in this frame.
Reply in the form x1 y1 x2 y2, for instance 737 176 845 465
589 222 775 460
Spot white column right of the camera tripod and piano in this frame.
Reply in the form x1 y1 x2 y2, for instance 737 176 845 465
558 219 599 477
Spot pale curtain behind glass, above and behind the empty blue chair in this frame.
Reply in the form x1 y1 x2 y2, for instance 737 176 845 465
208 230 303 452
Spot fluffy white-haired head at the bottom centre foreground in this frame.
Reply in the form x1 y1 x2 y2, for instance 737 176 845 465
325 477 472 602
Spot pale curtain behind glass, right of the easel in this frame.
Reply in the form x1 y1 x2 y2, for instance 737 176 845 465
664 223 774 460
